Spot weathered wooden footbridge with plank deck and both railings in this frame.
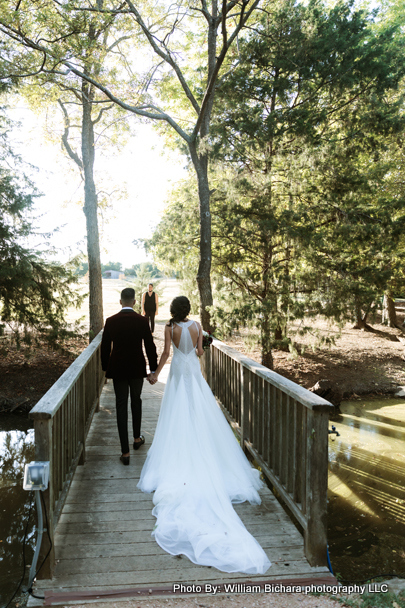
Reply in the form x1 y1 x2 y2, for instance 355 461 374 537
30 334 336 605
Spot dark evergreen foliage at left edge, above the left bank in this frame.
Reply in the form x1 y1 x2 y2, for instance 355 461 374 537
0 108 82 342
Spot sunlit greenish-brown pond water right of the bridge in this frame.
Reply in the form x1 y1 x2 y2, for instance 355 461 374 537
328 399 405 581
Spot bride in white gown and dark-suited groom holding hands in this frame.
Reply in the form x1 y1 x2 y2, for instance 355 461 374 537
101 286 271 574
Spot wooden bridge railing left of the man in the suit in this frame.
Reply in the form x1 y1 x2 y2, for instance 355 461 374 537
29 331 104 578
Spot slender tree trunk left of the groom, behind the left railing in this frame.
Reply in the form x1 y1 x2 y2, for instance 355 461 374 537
82 82 104 341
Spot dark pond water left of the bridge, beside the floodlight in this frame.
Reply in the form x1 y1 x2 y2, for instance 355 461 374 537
0 414 36 607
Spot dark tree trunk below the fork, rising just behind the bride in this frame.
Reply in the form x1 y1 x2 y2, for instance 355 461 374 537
189 142 213 331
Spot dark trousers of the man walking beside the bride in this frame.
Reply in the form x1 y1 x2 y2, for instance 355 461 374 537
113 378 143 454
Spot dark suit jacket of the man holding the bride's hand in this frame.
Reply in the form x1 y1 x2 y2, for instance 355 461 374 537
101 309 157 379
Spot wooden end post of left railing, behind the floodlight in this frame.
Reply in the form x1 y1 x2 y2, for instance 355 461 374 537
34 418 55 579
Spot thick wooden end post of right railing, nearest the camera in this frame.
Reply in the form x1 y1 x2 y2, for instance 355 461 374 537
304 410 328 566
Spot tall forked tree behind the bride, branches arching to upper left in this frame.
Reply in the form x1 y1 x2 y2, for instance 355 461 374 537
0 0 260 328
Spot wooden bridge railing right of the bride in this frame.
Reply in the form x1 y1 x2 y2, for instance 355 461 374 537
201 340 332 566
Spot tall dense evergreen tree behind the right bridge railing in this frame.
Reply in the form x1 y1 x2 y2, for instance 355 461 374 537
208 0 404 366
